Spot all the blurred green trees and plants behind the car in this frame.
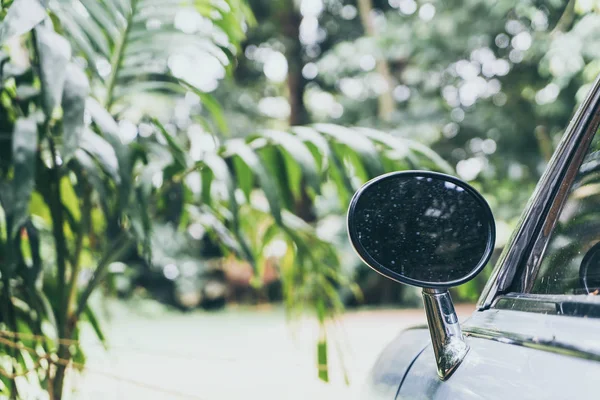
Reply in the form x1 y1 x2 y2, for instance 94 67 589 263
0 0 600 399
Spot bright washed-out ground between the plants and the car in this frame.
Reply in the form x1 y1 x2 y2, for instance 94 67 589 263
69 302 473 400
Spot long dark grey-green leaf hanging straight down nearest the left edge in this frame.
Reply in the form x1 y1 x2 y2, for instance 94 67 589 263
11 118 38 237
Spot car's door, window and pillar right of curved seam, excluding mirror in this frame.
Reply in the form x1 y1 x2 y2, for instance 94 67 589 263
396 80 600 399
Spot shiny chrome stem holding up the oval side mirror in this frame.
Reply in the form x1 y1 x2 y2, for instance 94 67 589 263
423 288 469 380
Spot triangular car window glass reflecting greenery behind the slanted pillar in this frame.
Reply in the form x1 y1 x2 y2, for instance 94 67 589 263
532 134 600 295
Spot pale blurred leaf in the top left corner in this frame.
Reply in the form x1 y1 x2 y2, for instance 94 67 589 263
0 0 46 44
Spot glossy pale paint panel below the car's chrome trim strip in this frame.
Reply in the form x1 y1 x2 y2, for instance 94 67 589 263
396 337 600 400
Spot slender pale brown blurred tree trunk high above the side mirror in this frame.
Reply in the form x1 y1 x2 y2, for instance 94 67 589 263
358 0 395 121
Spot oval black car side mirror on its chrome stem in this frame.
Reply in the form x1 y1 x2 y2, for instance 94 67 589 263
348 171 496 380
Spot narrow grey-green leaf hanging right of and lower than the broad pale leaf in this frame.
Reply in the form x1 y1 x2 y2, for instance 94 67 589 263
61 63 90 163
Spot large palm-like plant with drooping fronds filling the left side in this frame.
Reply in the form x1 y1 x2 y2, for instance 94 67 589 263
0 0 451 399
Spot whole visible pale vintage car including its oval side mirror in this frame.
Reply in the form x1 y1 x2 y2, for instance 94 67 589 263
348 74 600 399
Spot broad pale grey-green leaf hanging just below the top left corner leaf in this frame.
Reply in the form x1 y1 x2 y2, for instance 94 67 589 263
35 25 71 118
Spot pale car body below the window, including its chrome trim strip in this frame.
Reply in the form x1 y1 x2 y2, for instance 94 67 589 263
396 309 600 400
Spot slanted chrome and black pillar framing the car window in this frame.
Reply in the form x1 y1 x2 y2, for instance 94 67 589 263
477 75 600 311
